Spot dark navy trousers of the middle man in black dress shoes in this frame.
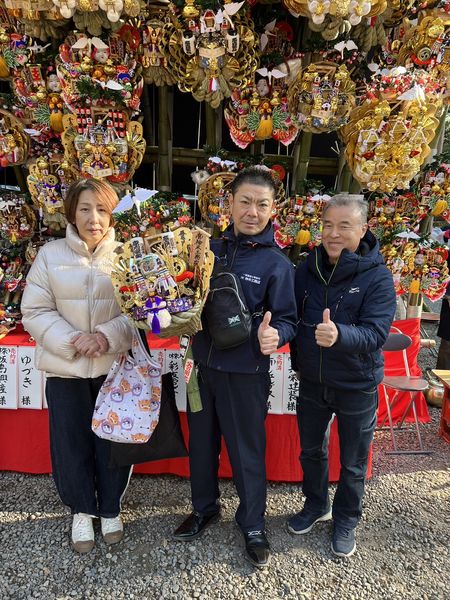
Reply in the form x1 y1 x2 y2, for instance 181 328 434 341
188 367 270 532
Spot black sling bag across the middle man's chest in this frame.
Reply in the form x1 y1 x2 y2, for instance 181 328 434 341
203 244 252 350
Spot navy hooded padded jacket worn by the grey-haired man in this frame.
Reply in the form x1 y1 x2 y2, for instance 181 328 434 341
291 231 396 391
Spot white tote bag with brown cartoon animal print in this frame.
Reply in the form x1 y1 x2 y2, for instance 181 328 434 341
92 330 161 444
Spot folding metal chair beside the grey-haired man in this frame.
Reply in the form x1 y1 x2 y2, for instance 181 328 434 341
377 327 432 454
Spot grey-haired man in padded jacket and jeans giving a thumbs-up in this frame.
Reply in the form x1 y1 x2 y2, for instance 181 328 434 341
287 194 395 556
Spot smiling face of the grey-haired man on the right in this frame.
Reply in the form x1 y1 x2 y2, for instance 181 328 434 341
322 206 367 264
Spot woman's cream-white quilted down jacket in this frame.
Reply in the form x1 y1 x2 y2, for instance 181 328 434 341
21 225 132 378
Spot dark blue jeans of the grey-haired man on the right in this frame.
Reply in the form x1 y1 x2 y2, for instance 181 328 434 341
297 380 378 528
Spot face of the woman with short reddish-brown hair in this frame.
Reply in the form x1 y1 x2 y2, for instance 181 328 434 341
75 190 111 252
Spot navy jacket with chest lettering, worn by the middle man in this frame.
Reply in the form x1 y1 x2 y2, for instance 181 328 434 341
192 223 297 373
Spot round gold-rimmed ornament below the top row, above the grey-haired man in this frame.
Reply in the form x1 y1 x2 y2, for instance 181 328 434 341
288 62 355 133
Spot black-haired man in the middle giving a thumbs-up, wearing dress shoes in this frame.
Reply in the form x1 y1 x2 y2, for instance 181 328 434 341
173 167 297 567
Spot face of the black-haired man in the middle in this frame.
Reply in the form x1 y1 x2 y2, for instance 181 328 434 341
229 183 274 235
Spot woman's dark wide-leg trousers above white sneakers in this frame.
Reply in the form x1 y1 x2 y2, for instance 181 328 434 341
45 377 131 517
